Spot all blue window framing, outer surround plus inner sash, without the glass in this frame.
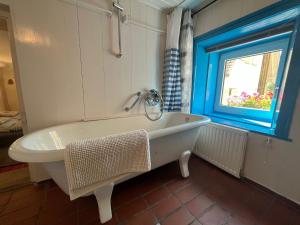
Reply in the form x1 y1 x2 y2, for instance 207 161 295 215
191 0 300 139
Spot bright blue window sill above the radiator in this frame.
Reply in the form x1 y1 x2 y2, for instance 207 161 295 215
208 113 292 142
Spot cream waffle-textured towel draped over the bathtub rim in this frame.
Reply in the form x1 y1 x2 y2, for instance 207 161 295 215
64 130 151 200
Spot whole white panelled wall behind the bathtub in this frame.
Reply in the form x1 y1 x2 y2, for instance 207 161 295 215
10 0 166 131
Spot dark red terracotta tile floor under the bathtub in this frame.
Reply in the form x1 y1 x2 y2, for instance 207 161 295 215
0 157 300 225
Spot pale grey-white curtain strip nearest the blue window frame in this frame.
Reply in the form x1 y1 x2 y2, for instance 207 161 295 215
180 10 193 113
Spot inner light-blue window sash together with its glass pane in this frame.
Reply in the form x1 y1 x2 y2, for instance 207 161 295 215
211 37 289 124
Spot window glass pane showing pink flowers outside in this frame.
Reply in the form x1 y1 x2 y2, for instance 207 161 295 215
220 50 282 111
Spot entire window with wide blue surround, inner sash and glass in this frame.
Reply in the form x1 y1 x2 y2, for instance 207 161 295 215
192 1 300 139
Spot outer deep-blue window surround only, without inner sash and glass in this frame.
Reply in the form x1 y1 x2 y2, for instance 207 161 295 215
191 0 300 140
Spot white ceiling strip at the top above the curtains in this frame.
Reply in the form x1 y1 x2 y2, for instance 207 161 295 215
139 0 214 11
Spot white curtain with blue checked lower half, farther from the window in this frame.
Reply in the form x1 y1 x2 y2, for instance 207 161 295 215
162 8 182 111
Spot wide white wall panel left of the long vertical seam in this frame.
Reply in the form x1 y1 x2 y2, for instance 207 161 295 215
11 0 83 131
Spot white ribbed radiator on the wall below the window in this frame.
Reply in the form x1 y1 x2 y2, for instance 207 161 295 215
194 123 248 178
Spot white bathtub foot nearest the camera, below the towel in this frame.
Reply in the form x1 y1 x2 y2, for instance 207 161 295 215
94 183 114 223
